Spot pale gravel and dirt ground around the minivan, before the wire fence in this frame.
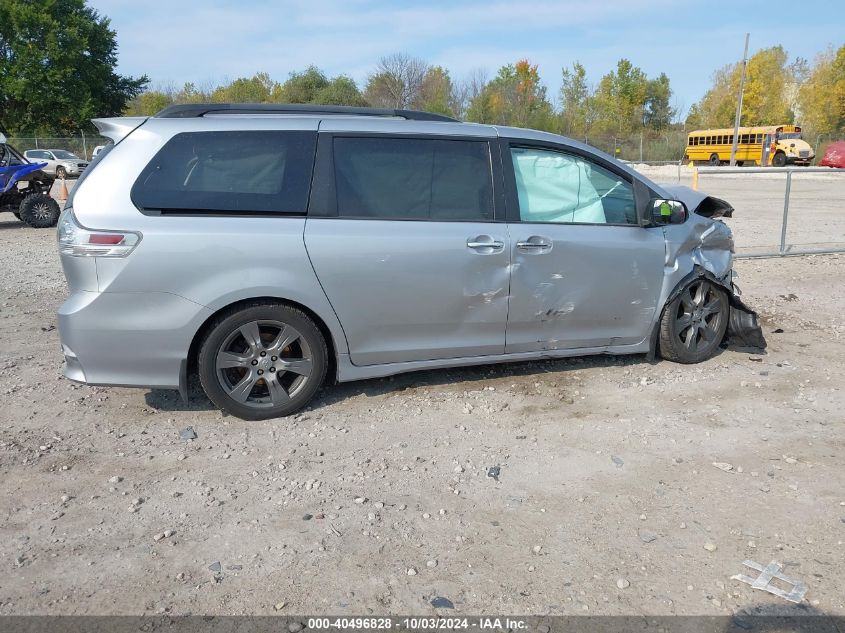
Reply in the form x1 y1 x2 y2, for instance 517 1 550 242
0 177 845 615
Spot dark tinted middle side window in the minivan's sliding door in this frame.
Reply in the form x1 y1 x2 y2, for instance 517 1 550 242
333 137 493 222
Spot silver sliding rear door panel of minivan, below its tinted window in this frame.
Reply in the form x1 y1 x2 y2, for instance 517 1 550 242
305 218 509 365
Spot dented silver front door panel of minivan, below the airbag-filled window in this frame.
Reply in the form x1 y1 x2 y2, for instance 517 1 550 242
505 224 665 353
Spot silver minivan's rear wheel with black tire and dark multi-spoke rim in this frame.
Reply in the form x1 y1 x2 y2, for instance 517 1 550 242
198 303 328 420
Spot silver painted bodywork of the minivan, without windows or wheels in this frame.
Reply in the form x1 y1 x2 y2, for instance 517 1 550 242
59 115 732 389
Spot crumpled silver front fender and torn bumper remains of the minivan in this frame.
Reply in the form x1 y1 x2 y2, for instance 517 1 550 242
649 186 766 359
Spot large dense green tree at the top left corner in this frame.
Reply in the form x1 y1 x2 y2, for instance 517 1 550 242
0 0 148 135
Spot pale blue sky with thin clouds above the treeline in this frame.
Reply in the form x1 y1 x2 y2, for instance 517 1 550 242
89 0 845 110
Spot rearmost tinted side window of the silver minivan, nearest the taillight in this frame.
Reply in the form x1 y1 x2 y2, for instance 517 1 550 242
131 130 317 215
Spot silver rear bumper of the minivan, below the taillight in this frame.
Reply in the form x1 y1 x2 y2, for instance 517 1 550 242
58 291 211 389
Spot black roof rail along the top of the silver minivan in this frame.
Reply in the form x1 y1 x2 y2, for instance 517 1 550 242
155 103 459 123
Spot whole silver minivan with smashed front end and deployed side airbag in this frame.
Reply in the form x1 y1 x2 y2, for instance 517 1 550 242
58 104 753 419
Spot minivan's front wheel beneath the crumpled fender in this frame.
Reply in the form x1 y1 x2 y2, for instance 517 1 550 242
660 278 730 363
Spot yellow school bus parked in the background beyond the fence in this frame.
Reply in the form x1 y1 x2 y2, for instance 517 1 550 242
684 125 815 167
